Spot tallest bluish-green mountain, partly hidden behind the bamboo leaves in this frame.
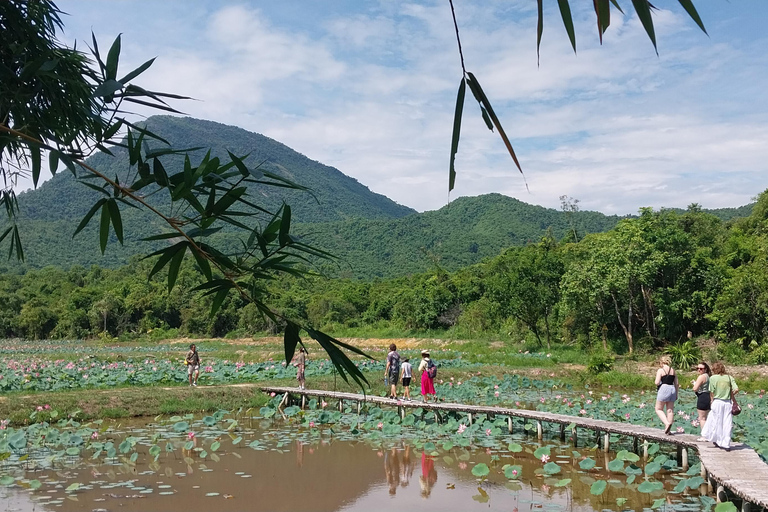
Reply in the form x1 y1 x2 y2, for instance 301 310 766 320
0 116 415 269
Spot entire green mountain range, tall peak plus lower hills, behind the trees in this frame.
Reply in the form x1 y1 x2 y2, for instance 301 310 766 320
0 116 752 279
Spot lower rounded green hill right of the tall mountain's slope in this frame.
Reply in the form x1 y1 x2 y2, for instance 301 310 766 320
296 194 620 278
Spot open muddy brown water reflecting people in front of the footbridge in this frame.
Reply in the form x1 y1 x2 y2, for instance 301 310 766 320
0 418 700 512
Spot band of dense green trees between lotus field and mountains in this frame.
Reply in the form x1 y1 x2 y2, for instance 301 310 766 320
0 187 768 362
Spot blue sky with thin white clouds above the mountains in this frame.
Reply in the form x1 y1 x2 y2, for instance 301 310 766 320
28 0 768 214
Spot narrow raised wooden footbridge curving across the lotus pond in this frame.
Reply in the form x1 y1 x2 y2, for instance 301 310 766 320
261 387 768 512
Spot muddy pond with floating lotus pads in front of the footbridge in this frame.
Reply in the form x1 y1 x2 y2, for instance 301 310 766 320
0 388 736 512
